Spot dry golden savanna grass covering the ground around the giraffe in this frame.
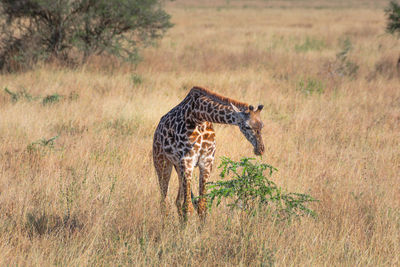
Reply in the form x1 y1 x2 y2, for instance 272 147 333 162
0 0 400 266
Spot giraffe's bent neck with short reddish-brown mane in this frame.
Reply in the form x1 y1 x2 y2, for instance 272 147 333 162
189 87 248 125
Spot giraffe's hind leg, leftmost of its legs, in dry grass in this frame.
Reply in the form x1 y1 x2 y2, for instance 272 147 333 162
154 155 172 215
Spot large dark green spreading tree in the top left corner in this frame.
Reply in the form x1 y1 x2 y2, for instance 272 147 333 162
0 0 172 70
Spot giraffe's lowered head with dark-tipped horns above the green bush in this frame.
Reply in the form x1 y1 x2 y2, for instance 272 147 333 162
231 104 264 155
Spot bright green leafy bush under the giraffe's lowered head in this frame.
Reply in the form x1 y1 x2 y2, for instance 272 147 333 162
206 157 316 220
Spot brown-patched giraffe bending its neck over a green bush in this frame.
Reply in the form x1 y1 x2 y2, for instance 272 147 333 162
153 87 264 221
